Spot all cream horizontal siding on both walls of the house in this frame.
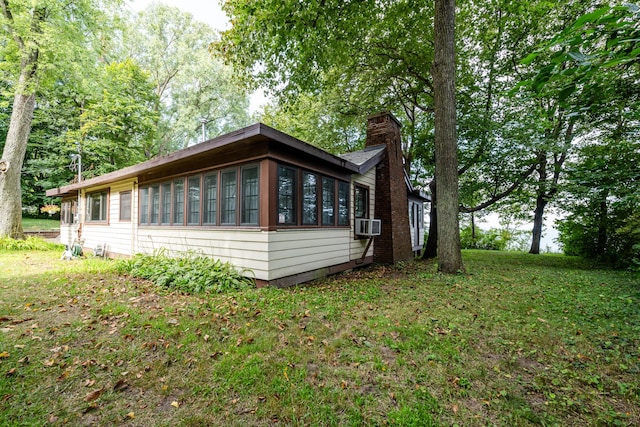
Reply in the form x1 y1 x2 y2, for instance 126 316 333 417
70 172 375 281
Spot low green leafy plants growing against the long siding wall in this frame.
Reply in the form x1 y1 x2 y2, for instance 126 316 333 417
117 250 253 293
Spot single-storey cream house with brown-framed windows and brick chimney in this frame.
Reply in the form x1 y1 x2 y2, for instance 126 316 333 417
47 113 427 286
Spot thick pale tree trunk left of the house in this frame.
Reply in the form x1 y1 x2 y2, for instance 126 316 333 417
0 73 35 239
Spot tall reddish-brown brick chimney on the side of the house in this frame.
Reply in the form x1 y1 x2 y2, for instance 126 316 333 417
365 112 413 264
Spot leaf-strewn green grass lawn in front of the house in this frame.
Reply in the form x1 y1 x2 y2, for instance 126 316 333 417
0 251 640 426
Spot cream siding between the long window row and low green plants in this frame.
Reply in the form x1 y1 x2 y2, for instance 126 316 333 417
136 227 269 280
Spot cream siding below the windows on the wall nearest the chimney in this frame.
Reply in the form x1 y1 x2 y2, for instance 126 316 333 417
268 228 351 280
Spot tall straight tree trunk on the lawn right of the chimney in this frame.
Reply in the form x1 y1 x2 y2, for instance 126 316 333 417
432 0 464 274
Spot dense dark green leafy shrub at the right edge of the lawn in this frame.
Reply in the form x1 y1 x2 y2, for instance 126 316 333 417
558 135 640 268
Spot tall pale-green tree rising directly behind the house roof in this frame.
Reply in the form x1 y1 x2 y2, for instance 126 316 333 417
122 3 250 156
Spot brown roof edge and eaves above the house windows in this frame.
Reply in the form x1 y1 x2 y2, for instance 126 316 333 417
46 123 359 197
